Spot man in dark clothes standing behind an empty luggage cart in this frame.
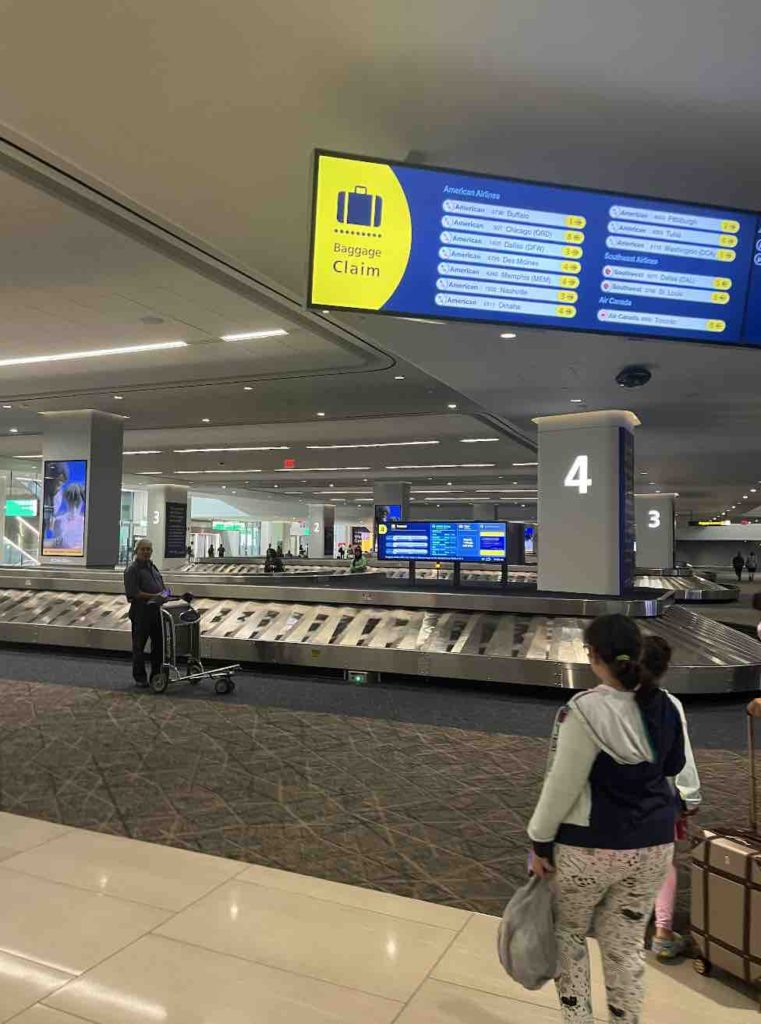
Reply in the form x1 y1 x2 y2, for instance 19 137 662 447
124 538 168 689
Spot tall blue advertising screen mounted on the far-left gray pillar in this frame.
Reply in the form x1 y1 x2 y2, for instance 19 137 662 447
40 459 87 555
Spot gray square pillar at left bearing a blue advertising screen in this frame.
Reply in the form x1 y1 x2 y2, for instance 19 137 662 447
40 409 124 566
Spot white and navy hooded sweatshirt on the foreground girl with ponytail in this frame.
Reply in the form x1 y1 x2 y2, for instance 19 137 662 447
529 684 685 857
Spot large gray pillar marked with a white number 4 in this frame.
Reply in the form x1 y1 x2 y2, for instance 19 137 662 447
534 410 639 595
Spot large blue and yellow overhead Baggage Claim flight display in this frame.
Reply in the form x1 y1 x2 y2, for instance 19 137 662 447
308 153 761 345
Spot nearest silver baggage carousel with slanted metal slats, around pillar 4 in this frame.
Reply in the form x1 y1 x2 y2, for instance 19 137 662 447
0 565 761 693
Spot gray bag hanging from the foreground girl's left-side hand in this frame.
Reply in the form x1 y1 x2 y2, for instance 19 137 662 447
497 874 557 991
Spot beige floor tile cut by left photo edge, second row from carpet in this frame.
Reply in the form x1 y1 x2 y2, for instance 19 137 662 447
0 865 167 974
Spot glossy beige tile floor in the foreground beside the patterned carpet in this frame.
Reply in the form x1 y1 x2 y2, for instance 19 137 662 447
0 813 759 1024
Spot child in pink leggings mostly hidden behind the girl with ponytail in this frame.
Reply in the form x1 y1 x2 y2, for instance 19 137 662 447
642 636 702 963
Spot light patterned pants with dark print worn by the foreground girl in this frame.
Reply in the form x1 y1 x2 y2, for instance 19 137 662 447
553 843 674 1024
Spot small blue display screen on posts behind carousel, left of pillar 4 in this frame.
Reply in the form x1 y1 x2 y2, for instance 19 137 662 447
378 522 507 562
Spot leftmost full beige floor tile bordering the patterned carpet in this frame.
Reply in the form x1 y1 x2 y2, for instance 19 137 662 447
4 829 243 910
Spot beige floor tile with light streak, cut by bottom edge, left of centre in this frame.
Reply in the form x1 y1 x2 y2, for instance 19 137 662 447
49 935 403 1024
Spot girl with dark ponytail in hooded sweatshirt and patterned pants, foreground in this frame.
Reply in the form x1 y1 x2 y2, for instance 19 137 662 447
529 615 685 1024
